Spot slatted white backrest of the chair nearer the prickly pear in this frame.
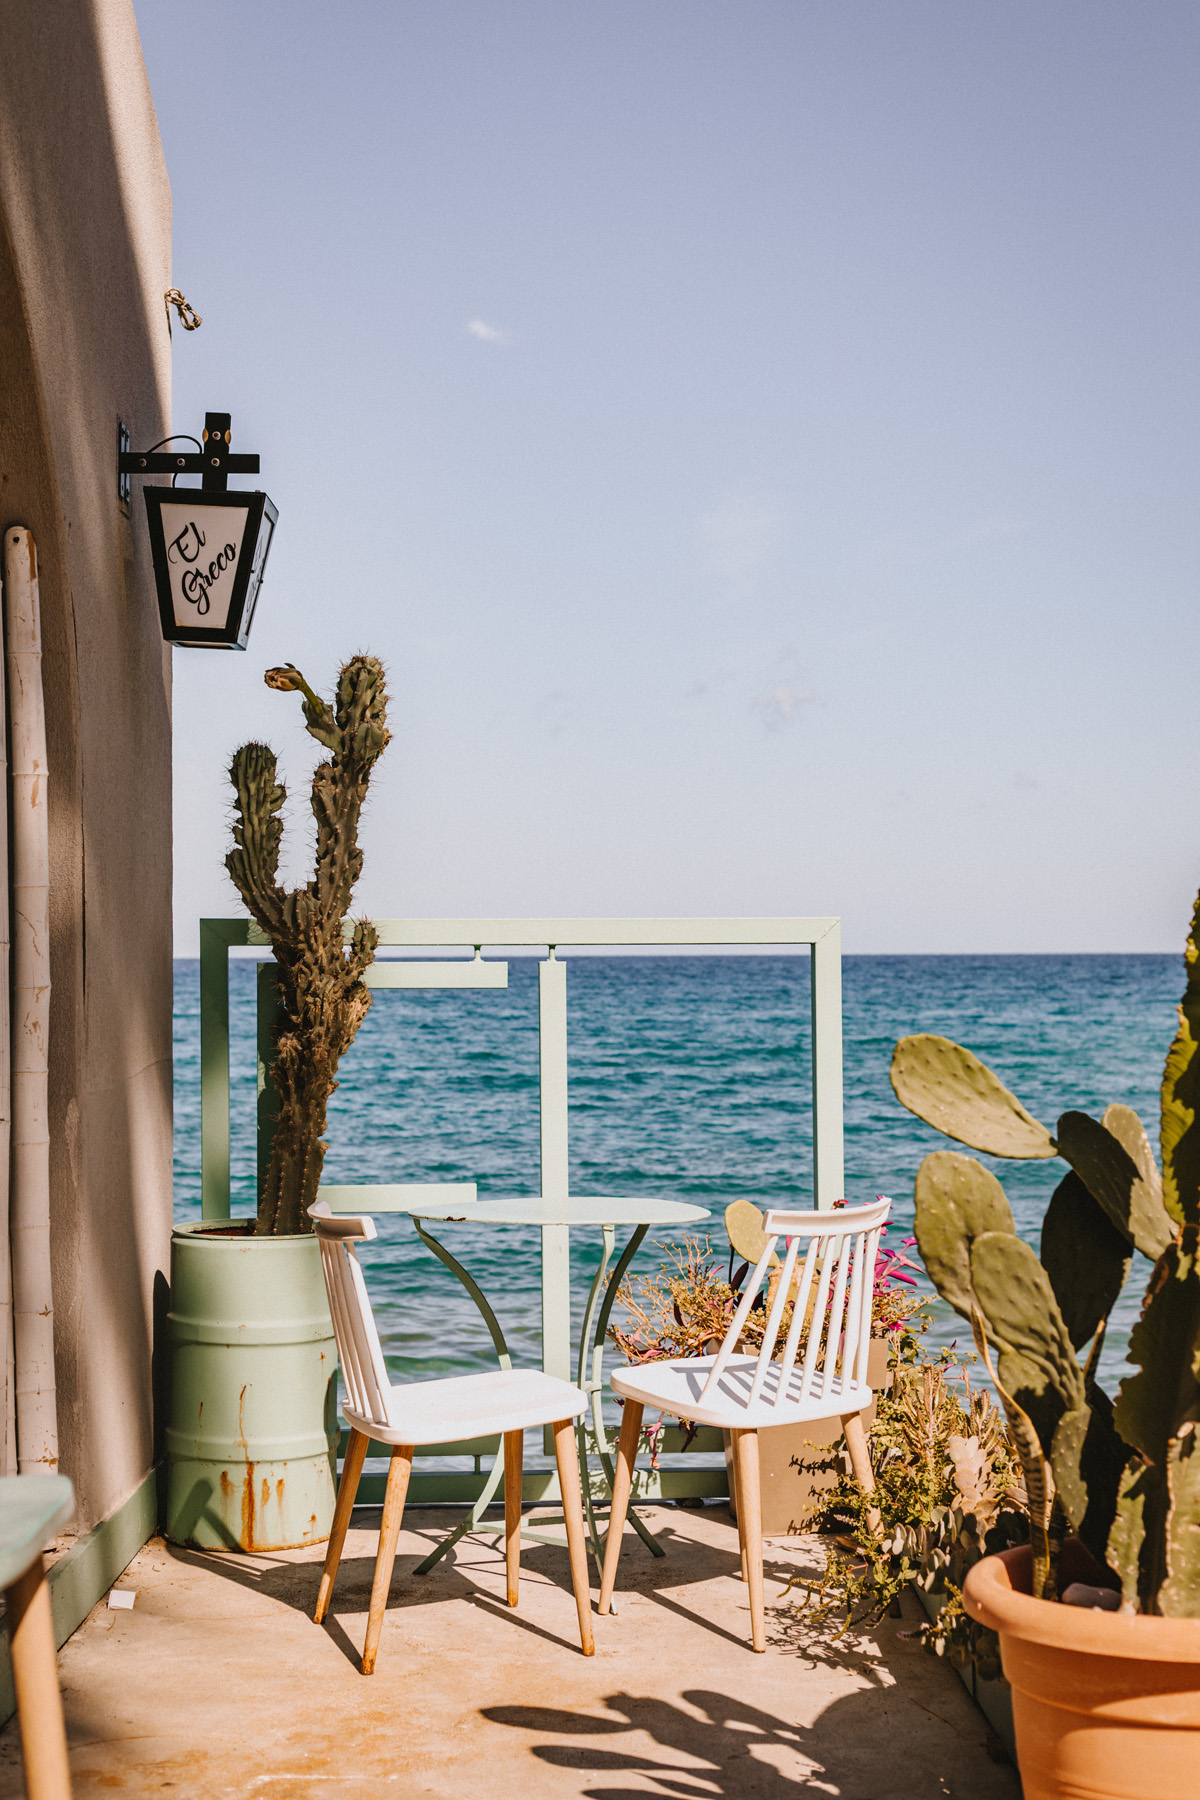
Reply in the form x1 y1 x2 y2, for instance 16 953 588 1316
700 1195 892 1406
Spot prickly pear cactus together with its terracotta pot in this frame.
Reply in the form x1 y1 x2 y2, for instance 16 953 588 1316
892 902 1200 1800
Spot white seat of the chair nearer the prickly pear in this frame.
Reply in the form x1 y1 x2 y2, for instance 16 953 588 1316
612 1355 874 1431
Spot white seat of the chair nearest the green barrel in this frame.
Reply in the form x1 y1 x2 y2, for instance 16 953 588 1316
342 1368 588 1447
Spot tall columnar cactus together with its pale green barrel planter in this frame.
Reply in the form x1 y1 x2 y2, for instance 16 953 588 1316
166 657 389 1550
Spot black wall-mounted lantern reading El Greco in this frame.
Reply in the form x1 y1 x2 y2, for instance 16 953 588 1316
117 412 279 650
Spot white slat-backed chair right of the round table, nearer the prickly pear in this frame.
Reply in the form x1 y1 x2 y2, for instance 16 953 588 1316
599 1199 892 1651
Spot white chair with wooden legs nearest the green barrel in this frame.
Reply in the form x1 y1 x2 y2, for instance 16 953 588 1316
308 1201 594 1676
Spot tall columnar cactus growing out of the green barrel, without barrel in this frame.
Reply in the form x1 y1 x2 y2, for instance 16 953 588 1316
225 657 390 1235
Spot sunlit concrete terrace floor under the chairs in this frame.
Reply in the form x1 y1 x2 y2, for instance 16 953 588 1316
0 1507 1020 1800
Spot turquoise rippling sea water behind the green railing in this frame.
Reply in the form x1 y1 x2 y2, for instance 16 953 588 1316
175 954 1184 1384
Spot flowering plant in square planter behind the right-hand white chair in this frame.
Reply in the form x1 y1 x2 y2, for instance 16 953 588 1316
610 1201 919 1537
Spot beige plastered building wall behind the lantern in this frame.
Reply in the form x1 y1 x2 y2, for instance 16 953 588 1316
0 0 171 1530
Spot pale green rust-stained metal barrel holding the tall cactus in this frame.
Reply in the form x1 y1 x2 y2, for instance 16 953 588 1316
166 1222 338 1550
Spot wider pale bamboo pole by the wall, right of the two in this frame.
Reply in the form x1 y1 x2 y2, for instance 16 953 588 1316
4 526 58 1474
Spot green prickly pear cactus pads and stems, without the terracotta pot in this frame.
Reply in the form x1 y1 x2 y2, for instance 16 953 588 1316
892 900 1200 1618
